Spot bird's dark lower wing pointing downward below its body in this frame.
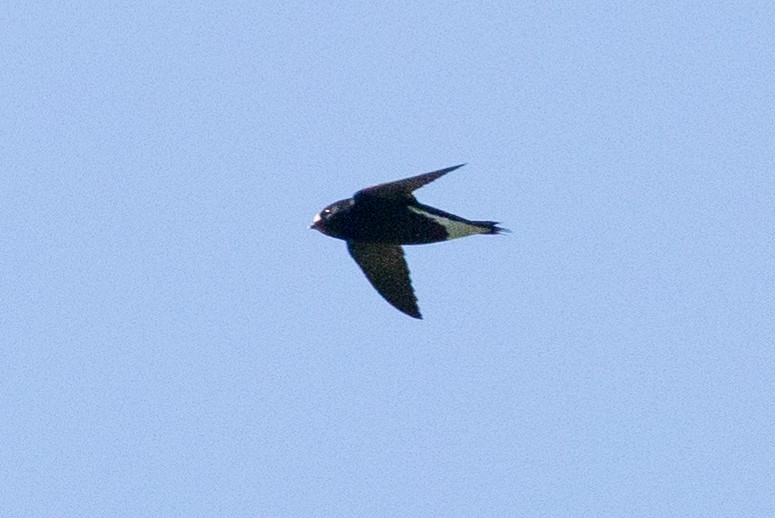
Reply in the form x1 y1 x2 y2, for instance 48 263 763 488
347 241 422 318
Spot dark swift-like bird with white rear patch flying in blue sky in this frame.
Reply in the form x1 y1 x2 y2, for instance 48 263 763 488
310 164 510 319
